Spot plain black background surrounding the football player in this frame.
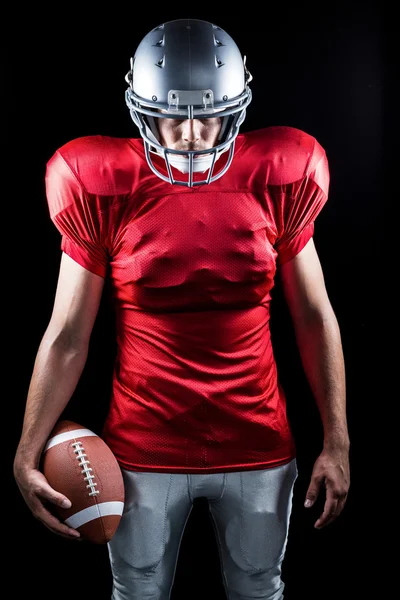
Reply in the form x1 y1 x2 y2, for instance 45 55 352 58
7 2 396 600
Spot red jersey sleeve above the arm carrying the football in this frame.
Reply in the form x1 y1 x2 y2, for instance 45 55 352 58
45 150 108 277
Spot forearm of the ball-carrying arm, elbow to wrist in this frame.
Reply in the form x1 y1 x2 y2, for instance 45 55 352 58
16 334 88 467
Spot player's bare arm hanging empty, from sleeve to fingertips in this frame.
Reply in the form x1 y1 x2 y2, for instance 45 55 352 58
281 238 350 528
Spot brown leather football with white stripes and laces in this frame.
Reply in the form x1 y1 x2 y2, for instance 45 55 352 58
42 420 125 544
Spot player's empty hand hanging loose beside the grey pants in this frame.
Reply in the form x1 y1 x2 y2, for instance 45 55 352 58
304 448 350 529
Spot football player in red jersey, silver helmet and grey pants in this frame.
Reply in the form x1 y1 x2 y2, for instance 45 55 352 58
14 19 350 600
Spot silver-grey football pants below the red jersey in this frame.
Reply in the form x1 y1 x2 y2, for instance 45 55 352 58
108 459 297 600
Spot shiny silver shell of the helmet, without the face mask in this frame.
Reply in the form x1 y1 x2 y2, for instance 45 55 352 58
131 19 245 106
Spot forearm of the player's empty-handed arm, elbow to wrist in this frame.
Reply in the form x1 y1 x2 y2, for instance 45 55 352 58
295 312 349 448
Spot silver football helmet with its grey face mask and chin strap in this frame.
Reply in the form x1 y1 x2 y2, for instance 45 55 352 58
125 19 252 187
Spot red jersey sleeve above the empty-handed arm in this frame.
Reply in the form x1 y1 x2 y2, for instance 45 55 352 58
275 141 329 265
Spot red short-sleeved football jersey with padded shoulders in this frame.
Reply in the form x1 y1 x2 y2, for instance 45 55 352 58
46 126 329 473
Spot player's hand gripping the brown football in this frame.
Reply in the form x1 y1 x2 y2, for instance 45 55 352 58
14 461 80 540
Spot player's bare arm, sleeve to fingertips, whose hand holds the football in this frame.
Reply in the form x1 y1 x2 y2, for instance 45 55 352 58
14 253 104 537
